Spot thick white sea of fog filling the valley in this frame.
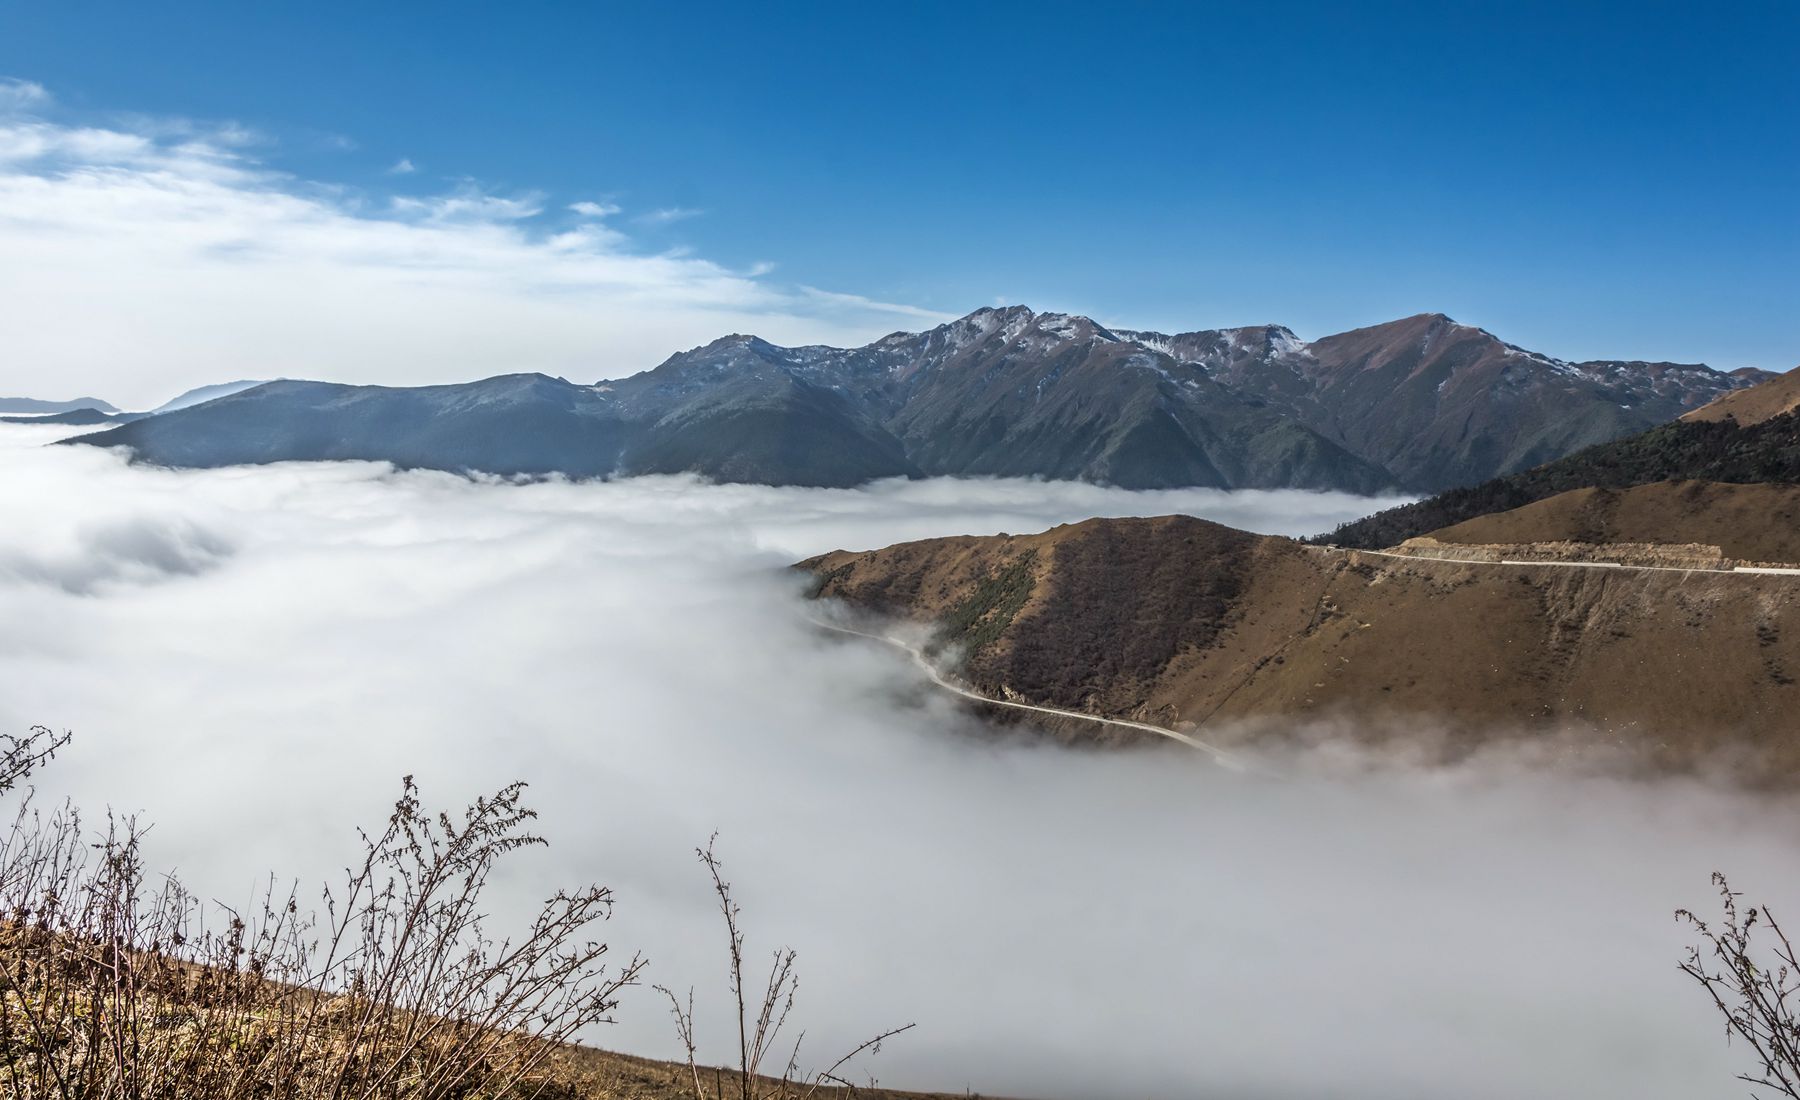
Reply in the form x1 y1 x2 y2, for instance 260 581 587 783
0 427 1796 1100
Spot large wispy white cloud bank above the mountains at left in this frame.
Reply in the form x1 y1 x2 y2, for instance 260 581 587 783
0 79 943 407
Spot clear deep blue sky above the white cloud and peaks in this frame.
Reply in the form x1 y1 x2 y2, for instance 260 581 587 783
0 0 1800 369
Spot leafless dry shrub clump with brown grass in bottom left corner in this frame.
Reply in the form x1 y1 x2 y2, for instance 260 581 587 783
0 727 643 1100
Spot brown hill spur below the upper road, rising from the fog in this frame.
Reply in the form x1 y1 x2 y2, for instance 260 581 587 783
799 517 1800 778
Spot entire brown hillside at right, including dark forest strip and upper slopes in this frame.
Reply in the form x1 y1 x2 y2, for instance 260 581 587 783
799 371 1800 785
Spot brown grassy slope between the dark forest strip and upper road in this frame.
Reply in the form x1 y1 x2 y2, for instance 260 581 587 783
1431 481 1800 564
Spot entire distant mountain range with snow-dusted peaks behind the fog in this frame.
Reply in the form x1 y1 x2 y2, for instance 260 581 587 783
79 306 1762 493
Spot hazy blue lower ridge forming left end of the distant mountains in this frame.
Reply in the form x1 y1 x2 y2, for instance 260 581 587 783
76 374 918 486
